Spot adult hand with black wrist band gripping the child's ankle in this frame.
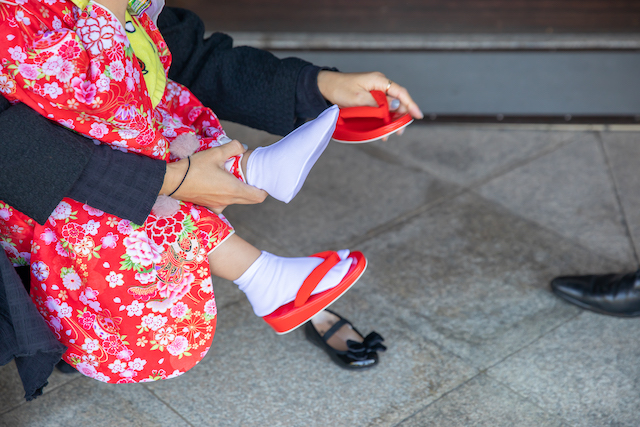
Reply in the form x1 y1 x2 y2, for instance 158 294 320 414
165 140 267 213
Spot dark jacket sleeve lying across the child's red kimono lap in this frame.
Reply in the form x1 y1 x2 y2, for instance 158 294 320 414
0 97 166 224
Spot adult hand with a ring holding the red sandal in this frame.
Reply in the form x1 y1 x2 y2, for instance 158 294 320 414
318 70 424 119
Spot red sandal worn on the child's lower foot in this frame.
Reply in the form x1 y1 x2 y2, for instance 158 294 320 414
263 251 367 335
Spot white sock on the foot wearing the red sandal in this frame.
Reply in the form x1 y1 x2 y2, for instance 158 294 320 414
233 249 351 317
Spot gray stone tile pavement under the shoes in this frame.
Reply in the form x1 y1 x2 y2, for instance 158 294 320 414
0 124 640 427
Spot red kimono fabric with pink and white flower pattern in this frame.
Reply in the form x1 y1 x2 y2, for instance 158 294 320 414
0 0 241 383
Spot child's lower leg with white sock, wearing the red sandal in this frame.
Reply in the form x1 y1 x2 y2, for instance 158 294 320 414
209 234 351 317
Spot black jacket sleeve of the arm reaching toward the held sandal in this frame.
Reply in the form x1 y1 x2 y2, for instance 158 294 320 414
158 8 317 135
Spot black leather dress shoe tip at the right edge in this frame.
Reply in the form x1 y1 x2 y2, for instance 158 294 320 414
551 270 640 317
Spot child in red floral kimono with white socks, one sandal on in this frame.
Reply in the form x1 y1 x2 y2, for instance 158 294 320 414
0 0 366 383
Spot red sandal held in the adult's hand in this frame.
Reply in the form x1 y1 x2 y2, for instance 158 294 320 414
333 90 413 144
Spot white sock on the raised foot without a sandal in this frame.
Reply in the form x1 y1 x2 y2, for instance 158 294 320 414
245 105 340 203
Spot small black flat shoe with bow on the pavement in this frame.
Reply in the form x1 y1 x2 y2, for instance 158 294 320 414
304 310 387 369
